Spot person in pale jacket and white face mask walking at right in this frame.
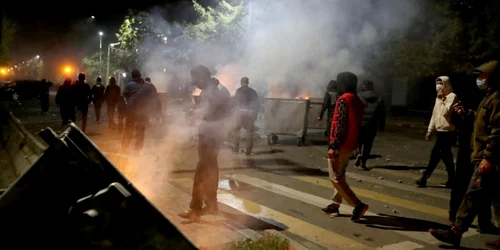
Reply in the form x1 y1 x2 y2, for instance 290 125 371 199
416 76 458 188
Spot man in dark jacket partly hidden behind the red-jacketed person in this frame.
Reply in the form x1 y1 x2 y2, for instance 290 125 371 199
354 81 385 170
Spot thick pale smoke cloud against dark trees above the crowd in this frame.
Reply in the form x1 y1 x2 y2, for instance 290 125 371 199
137 0 423 98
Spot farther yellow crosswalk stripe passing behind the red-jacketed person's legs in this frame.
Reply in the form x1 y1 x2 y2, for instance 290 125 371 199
289 176 448 219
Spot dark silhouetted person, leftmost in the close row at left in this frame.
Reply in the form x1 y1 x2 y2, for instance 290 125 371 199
56 77 75 126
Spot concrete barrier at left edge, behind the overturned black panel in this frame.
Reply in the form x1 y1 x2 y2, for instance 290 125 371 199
0 105 47 177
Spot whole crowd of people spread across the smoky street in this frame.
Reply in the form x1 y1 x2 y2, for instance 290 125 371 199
47 61 500 249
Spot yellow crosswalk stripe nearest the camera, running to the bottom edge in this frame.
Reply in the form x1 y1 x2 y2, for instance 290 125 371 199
173 178 374 250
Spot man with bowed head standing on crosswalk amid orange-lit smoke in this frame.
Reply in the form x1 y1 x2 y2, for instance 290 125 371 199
178 65 231 220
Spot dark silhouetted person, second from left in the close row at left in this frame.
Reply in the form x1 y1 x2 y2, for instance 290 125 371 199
72 73 92 132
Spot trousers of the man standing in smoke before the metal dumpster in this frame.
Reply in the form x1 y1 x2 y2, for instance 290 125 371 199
230 112 255 154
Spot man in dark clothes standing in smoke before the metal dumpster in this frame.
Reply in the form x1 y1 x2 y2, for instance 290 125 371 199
231 77 259 156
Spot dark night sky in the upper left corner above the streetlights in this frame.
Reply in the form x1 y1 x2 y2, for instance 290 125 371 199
1 0 193 78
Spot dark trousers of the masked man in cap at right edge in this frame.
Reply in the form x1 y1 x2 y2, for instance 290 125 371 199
454 166 500 232
